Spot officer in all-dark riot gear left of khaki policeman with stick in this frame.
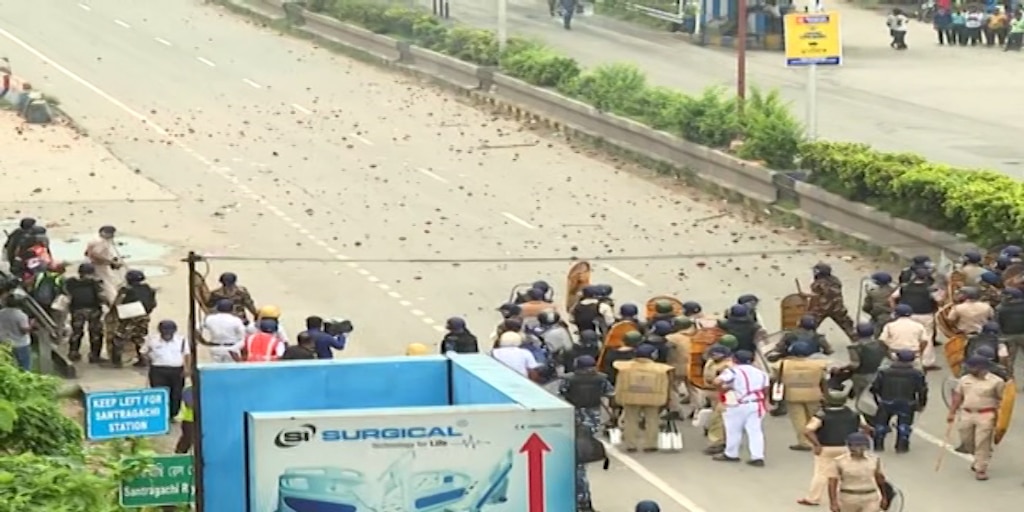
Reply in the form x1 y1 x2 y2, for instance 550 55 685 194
871 350 928 454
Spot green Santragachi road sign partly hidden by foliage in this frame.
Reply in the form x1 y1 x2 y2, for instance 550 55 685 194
121 455 196 507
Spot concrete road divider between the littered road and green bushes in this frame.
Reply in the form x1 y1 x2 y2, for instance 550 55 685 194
222 0 976 258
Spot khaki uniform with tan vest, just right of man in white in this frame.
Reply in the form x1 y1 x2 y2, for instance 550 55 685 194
778 357 829 449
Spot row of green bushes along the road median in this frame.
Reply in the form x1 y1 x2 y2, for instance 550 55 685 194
311 0 1024 245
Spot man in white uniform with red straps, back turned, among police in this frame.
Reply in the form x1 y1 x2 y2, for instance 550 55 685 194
713 350 769 467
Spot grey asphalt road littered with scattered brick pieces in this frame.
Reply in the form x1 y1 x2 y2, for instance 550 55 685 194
0 0 1024 512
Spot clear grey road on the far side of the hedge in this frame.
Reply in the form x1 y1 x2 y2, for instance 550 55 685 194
452 0 1024 177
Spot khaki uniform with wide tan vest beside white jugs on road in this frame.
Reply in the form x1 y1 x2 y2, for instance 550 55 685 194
612 358 674 451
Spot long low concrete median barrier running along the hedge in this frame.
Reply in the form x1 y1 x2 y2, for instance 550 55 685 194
216 0 977 261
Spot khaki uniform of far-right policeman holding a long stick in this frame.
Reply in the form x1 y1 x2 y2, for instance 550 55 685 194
956 374 1006 473
